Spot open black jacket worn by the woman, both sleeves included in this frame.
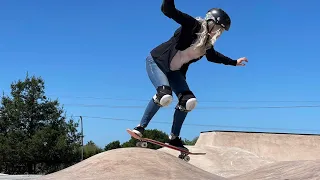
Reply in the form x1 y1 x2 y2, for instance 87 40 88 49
151 0 237 76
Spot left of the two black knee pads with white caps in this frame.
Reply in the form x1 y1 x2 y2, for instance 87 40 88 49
153 86 173 107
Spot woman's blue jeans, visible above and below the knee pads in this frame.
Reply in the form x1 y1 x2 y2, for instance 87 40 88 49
140 55 189 136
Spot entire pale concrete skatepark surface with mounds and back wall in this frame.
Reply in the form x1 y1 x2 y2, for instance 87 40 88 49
16 131 320 180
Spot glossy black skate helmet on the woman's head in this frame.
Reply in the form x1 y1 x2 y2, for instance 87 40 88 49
205 8 231 31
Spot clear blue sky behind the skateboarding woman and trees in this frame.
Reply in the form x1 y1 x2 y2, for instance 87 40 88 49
0 0 320 147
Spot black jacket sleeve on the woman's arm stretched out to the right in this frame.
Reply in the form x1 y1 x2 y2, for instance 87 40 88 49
206 48 237 66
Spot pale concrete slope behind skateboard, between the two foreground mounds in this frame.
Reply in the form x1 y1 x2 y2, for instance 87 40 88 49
159 146 274 178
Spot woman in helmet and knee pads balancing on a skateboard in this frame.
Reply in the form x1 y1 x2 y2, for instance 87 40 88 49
133 0 248 149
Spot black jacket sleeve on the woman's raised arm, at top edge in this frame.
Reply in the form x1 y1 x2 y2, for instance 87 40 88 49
161 0 197 27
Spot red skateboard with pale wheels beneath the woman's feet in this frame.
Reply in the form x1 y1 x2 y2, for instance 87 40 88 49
127 129 206 162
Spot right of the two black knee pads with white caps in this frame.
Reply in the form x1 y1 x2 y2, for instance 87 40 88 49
176 91 197 112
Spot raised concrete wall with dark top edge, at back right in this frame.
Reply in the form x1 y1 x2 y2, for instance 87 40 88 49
195 131 320 161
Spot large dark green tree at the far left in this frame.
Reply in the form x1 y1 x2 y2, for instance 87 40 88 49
0 75 81 174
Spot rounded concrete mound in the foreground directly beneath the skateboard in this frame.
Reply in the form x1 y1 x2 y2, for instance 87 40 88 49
39 148 225 180
